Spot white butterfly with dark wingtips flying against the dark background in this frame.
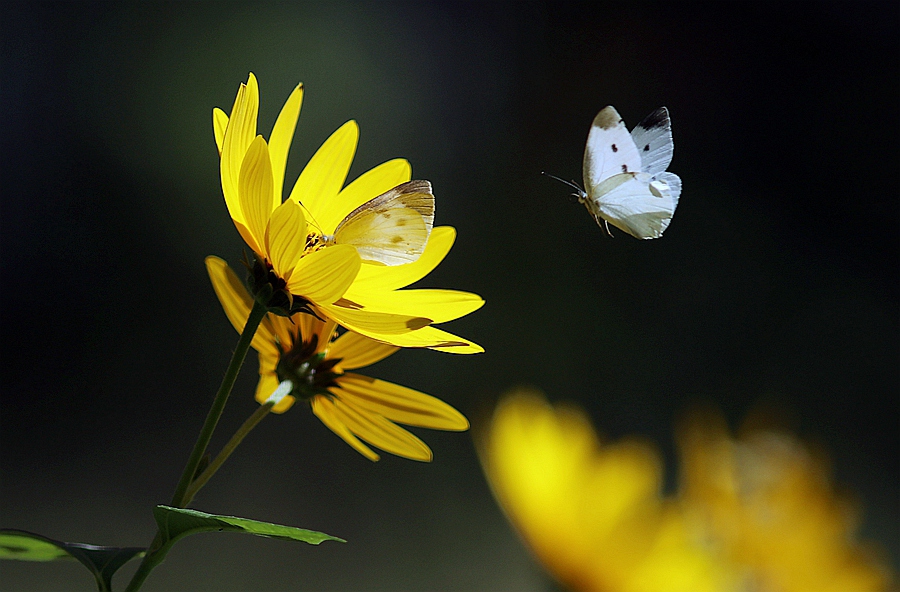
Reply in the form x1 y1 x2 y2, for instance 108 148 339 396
560 107 681 239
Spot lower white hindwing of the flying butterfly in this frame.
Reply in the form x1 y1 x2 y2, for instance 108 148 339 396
585 173 681 239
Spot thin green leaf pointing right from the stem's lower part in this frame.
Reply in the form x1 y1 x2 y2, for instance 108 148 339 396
153 506 347 545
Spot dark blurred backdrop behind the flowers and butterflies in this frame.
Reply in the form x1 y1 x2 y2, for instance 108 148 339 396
0 2 900 591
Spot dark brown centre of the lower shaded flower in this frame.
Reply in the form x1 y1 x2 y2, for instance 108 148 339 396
275 335 343 400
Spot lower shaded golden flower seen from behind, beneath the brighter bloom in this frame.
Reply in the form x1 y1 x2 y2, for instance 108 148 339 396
206 257 469 461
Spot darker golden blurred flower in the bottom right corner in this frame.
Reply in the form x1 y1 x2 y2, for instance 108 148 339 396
680 414 890 592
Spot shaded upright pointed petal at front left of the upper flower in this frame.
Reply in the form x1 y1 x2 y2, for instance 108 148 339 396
238 136 276 253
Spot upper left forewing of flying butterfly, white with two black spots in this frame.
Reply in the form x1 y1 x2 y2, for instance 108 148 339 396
584 107 642 194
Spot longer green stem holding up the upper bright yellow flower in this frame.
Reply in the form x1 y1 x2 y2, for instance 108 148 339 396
126 301 266 592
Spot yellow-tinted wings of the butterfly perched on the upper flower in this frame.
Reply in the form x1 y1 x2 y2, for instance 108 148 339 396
329 181 434 265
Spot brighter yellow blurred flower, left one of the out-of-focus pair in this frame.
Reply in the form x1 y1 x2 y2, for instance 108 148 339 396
479 389 726 592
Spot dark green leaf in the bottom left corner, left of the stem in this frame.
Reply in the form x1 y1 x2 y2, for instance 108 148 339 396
0 528 144 592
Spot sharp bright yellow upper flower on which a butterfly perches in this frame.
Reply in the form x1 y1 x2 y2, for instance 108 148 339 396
213 74 484 353
